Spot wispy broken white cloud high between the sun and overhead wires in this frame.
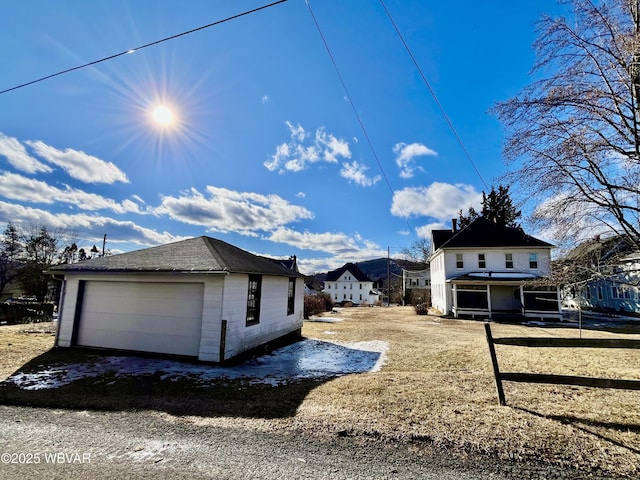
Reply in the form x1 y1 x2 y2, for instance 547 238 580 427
264 121 351 173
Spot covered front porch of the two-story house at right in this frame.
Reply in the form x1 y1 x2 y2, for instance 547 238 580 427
447 272 562 320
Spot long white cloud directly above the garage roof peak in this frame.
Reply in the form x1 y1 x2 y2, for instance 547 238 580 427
155 186 314 236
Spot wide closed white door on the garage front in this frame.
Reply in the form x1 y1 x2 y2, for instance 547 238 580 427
77 281 204 356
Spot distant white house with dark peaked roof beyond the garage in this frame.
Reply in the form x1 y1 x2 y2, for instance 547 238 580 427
324 263 380 305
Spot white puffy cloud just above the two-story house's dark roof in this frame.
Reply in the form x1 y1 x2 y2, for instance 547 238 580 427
391 182 482 221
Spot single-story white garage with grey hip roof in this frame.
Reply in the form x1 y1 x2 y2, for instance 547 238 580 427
50 237 304 362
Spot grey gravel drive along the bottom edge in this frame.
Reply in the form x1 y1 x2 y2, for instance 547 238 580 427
0 406 610 480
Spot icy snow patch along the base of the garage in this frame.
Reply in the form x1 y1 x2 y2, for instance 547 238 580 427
6 339 389 390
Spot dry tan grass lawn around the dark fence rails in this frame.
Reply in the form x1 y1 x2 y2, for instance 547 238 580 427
0 307 640 477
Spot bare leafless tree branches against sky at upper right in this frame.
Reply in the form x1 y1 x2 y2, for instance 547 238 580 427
493 0 640 248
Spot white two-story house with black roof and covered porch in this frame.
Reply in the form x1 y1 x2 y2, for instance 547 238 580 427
431 218 562 319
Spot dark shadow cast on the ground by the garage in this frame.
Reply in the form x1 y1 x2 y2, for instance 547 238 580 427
0 341 381 419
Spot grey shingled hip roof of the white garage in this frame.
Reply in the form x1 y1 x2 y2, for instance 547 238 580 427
51 236 300 277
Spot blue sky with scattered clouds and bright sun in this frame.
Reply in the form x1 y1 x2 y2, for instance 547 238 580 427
0 0 559 273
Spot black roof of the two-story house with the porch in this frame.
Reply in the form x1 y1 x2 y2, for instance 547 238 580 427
432 217 553 250
